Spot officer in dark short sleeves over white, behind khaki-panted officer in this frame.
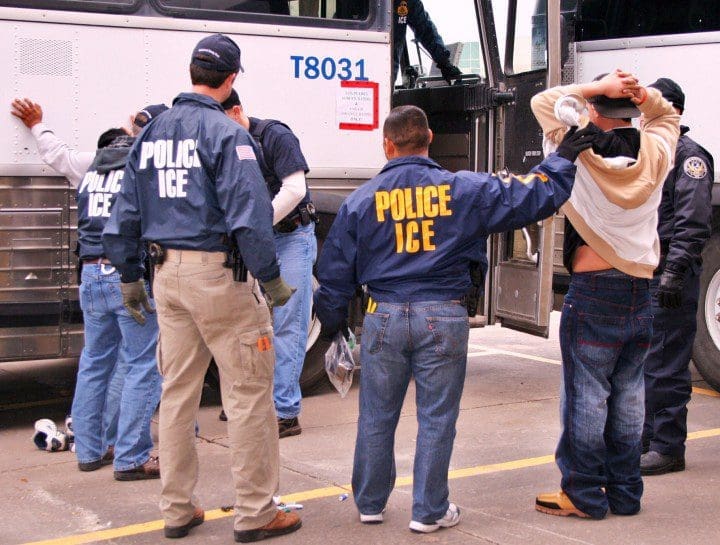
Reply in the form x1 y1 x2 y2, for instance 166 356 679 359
221 89 317 438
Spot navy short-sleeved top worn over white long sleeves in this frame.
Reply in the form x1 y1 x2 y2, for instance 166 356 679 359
249 117 310 212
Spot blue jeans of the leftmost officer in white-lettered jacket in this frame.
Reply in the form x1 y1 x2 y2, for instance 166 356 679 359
72 265 161 471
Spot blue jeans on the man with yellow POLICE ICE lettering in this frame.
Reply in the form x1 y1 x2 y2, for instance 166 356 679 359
352 301 469 524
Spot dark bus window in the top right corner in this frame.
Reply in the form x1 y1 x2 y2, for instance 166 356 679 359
576 0 720 41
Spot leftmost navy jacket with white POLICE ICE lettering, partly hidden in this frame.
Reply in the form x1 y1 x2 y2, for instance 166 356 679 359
77 136 135 260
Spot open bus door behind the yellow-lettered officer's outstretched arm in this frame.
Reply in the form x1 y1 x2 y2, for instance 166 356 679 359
486 0 561 337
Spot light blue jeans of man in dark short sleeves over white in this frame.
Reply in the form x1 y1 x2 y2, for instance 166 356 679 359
273 223 317 418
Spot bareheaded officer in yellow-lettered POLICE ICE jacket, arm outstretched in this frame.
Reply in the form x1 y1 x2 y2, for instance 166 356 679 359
315 106 592 533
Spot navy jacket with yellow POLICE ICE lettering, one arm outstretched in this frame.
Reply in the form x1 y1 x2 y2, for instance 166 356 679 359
315 154 575 328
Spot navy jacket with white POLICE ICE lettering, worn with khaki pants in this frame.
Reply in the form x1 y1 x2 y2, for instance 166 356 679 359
103 93 280 282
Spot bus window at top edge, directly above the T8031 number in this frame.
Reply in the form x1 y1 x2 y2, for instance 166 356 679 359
159 0 369 21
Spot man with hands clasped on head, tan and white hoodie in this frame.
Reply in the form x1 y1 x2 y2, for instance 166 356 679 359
531 70 680 519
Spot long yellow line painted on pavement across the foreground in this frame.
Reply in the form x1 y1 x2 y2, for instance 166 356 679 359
23 428 720 545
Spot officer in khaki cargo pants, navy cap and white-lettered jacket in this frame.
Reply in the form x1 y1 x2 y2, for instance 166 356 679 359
103 34 301 542
